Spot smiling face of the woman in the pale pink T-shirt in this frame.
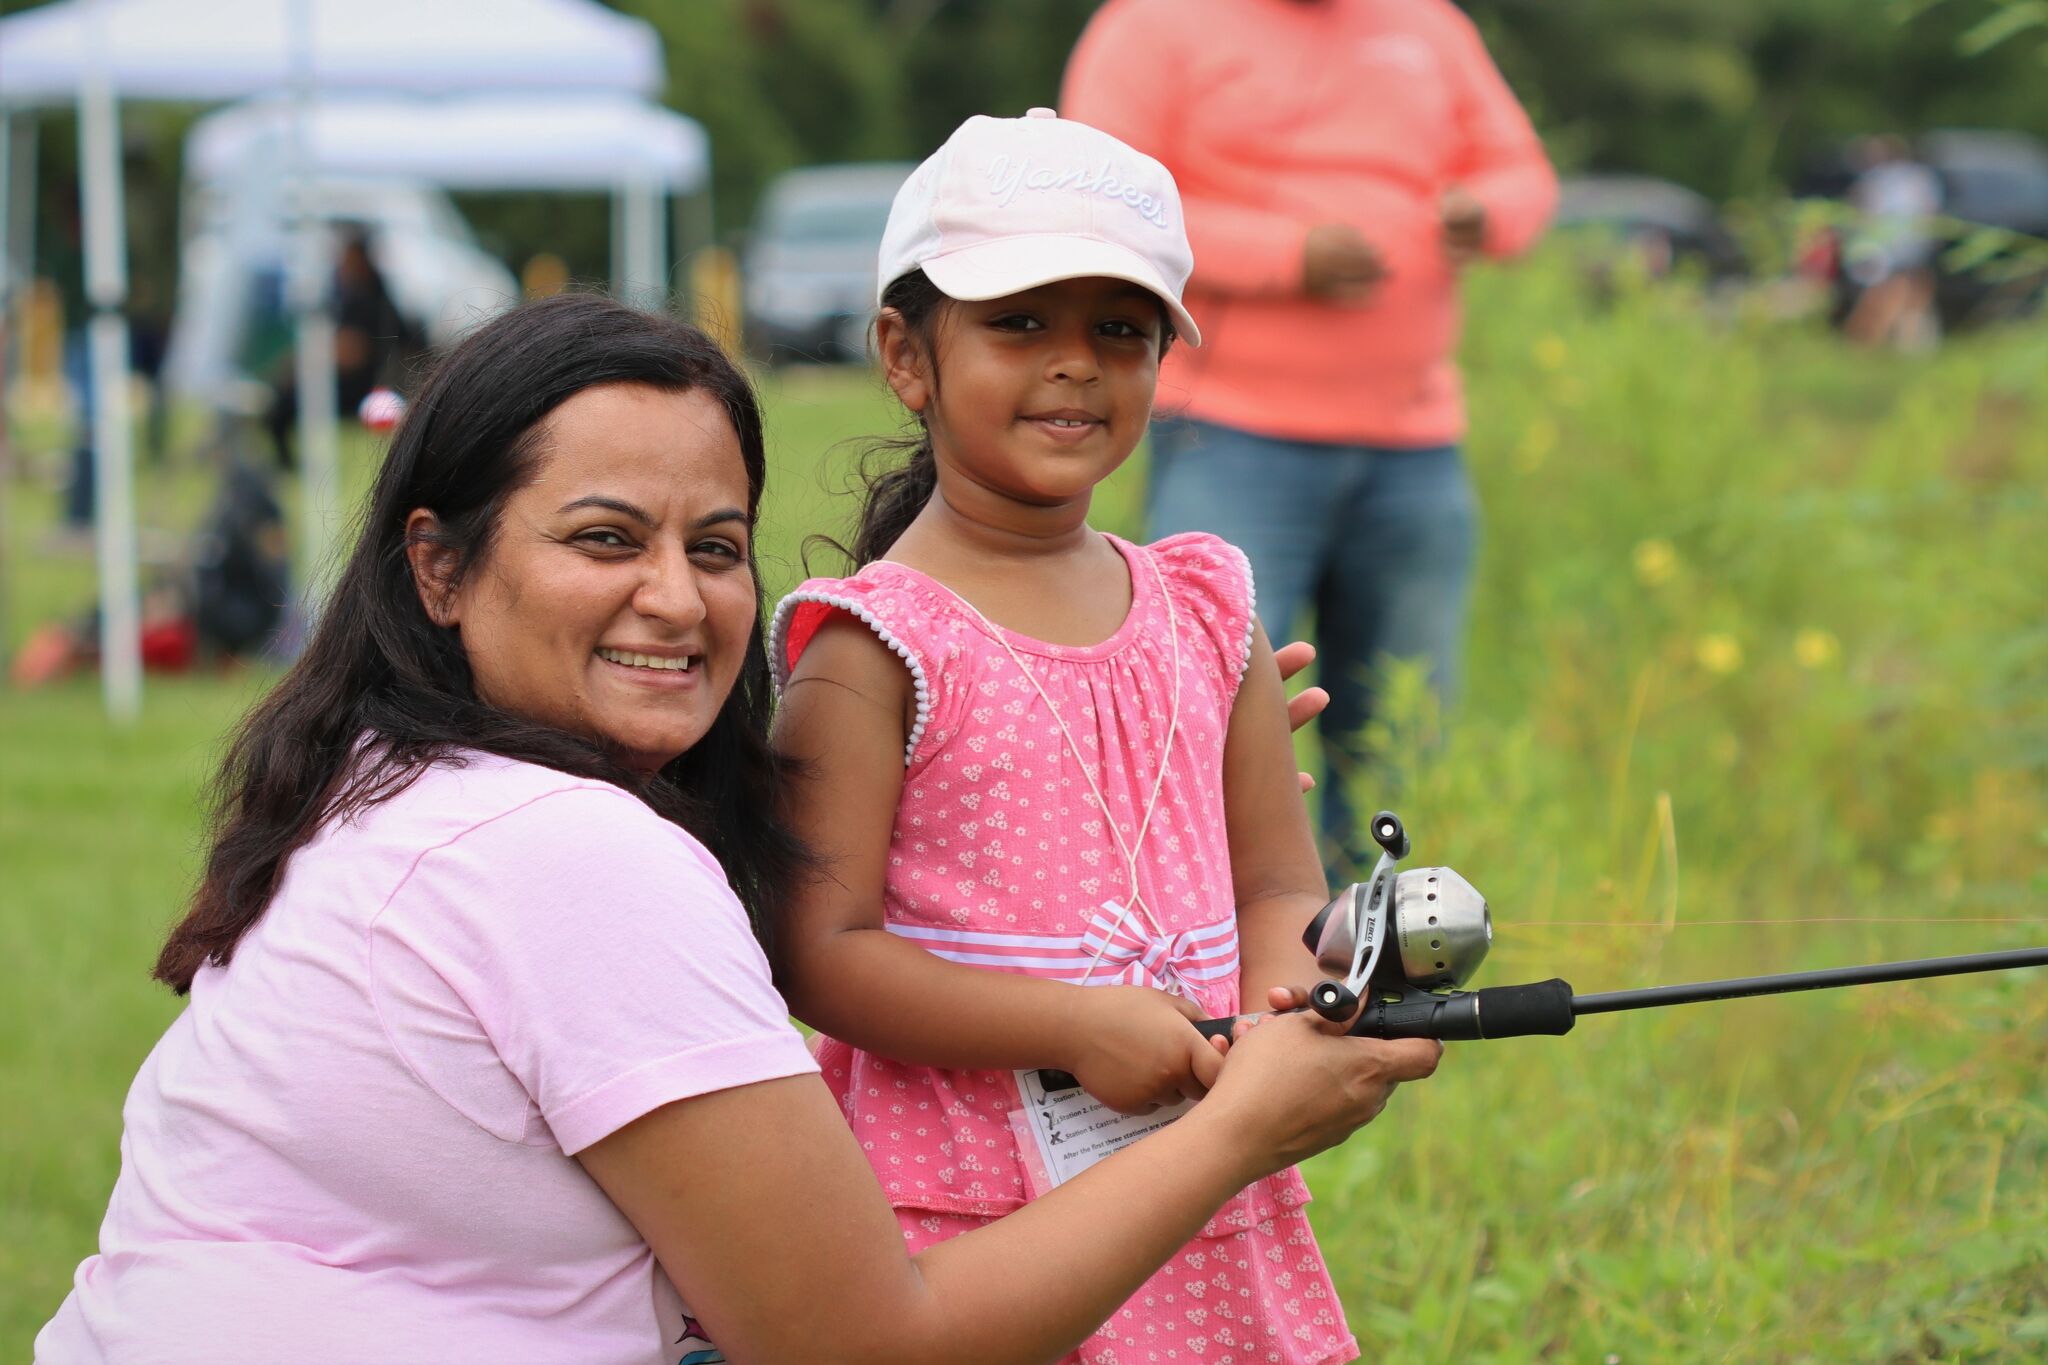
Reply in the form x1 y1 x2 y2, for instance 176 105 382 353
412 385 758 772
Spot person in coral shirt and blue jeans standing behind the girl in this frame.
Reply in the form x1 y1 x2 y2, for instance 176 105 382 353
1053 0 1556 874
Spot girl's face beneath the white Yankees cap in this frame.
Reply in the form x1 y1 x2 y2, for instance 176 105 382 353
883 278 1161 508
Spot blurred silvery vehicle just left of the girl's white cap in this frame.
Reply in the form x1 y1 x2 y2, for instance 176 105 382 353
741 162 913 360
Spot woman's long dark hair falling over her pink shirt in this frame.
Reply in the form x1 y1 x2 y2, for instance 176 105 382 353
156 295 809 995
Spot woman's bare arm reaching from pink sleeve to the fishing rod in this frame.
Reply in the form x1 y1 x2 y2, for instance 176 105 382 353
580 1002 1442 1365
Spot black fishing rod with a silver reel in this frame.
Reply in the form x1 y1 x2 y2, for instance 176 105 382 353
1245 810 2048 1042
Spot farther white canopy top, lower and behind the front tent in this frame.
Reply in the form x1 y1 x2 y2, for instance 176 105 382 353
184 94 711 305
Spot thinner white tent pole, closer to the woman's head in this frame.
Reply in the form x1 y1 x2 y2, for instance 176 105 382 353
291 0 342 609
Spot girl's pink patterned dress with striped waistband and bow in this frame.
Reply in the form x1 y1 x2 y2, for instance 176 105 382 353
768 534 1358 1365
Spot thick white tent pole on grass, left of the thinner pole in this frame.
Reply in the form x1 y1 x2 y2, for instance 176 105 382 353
78 0 141 722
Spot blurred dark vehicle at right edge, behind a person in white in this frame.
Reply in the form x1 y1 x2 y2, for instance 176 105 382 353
1794 129 2048 332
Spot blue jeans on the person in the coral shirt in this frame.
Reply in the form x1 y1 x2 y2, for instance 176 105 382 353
1147 417 1479 876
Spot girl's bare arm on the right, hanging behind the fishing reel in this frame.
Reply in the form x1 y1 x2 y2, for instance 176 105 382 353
1223 622 1329 1011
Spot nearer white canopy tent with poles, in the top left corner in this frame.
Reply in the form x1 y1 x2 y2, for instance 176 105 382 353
0 0 664 716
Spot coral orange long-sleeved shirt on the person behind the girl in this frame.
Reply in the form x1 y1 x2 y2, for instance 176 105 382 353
1061 0 1556 446
